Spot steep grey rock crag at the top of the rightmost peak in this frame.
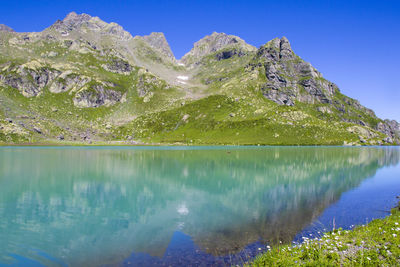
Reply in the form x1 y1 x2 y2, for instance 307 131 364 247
249 37 338 106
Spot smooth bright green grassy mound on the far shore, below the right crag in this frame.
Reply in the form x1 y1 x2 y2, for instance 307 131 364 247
114 95 384 145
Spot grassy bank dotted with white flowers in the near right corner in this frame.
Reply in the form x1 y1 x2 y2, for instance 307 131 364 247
247 203 400 266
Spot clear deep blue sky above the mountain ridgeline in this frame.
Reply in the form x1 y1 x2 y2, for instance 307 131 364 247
0 0 400 121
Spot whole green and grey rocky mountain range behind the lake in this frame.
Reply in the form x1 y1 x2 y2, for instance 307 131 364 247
0 12 400 145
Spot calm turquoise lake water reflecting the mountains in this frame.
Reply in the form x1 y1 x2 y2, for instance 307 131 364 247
0 147 400 266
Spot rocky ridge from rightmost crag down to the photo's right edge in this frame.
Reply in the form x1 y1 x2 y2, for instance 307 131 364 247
247 37 400 143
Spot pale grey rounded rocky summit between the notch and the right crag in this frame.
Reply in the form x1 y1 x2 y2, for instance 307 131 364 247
181 32 256 64
